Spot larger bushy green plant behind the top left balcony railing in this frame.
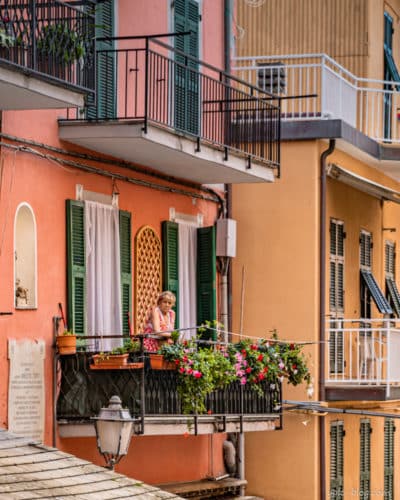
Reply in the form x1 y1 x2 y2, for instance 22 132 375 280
37 23 86 65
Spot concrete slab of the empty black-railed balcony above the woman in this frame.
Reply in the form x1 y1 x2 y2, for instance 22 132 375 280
59 121 274 184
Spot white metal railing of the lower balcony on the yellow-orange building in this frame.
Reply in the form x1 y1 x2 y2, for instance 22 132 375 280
326 318 400 396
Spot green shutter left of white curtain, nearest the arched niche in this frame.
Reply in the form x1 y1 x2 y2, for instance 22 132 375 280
66 200 86 335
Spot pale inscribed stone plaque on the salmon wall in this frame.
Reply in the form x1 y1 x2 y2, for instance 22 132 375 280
8 340 45 441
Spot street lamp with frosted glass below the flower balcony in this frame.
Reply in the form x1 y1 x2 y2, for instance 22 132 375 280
93 396 133 470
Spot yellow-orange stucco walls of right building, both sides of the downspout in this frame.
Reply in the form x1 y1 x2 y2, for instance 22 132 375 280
232 135 400 500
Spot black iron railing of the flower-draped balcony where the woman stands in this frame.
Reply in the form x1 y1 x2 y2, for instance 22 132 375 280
57 352 281 432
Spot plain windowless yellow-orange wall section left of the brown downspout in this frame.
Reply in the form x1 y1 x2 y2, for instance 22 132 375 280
232 142 319 500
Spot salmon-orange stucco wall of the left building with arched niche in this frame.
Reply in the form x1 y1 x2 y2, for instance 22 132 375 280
0 0 228 483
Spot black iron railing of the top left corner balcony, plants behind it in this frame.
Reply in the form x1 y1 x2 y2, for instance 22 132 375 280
0 0 95 92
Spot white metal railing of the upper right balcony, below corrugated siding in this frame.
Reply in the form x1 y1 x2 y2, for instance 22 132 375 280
232 54 400 143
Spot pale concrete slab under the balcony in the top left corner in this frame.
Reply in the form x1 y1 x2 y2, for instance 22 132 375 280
0 66 84 110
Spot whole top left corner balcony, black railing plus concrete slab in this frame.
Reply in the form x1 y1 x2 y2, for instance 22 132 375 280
0 0 94 110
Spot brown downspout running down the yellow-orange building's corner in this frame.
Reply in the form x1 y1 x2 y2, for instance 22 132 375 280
318 139 336 500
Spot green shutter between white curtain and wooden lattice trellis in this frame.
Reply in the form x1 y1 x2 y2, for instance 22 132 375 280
119 210 132 335
